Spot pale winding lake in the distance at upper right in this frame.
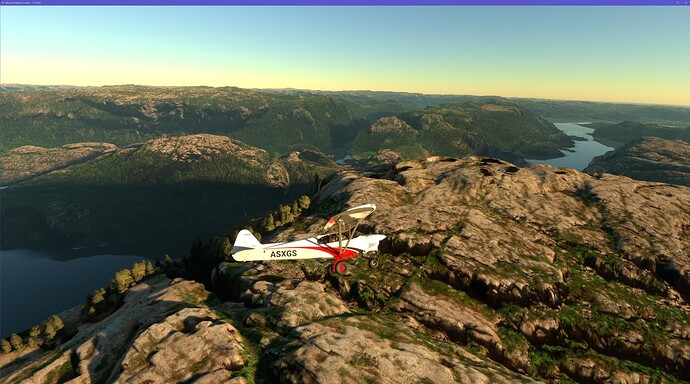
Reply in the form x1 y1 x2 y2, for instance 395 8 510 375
526 123 613 171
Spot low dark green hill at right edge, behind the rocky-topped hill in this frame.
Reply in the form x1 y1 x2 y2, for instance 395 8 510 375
585 121 690 145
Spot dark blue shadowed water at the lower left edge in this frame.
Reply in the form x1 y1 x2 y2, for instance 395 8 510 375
0 249 143 338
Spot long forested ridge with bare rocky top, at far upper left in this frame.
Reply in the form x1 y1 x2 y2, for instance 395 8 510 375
0 85 366 154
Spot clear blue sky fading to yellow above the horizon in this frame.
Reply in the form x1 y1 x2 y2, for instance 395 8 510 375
0 7 690 105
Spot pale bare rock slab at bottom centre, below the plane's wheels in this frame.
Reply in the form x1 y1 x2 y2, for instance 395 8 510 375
272 317 536 383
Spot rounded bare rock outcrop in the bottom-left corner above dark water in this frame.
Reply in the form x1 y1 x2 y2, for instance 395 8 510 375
0 278 245 383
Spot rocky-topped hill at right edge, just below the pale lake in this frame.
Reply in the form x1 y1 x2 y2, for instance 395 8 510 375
584 137 690 187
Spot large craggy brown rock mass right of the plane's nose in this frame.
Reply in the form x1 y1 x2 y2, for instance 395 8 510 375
306 157 690 382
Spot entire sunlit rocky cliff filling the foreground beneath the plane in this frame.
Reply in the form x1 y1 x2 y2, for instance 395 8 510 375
3 157 690 383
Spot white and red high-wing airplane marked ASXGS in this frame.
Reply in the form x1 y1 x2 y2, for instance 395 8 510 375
231 204 386 275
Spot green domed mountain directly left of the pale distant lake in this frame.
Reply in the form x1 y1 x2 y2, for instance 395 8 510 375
352 98 573 160
